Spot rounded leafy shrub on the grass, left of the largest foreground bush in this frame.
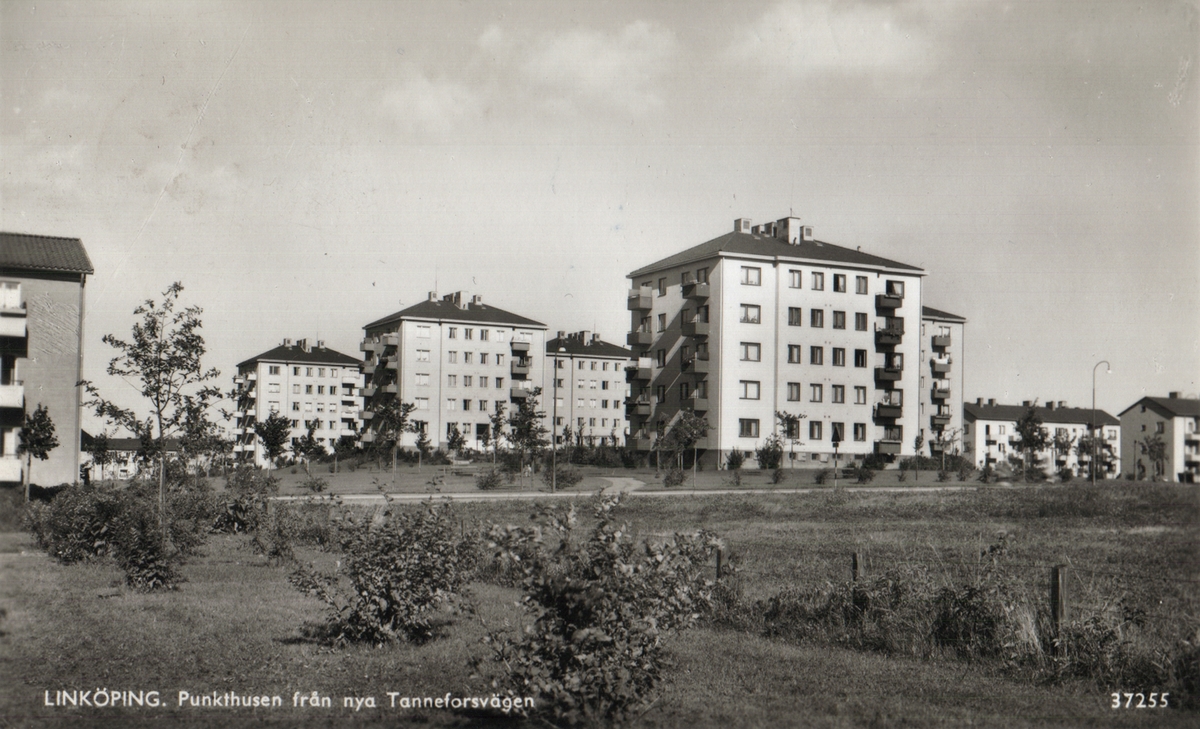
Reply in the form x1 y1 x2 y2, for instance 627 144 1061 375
290 504 475 645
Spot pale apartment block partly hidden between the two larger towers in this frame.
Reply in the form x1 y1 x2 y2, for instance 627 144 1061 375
541 331 634 446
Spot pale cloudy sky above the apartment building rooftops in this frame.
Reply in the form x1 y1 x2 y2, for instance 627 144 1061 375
0 0 1200 431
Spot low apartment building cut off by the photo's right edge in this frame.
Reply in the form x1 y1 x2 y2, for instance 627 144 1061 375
1121 392 1200 483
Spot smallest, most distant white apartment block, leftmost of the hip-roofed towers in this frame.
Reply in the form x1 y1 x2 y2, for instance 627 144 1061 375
233 339 362 466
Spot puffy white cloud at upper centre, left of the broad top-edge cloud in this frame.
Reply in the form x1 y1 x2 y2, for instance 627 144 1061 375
521 20 677 114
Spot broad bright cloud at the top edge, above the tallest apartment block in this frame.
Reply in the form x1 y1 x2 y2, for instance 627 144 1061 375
728 0 932 76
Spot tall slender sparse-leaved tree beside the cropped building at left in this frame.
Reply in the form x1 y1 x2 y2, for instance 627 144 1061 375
79 282 221 541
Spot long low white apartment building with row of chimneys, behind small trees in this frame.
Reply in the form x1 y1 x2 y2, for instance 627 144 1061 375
962 398 1121 478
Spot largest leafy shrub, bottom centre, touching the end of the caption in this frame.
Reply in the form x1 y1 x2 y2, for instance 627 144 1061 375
487 499 718 725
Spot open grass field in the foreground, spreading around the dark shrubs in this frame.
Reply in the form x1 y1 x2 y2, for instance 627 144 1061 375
0 482 1200 728
